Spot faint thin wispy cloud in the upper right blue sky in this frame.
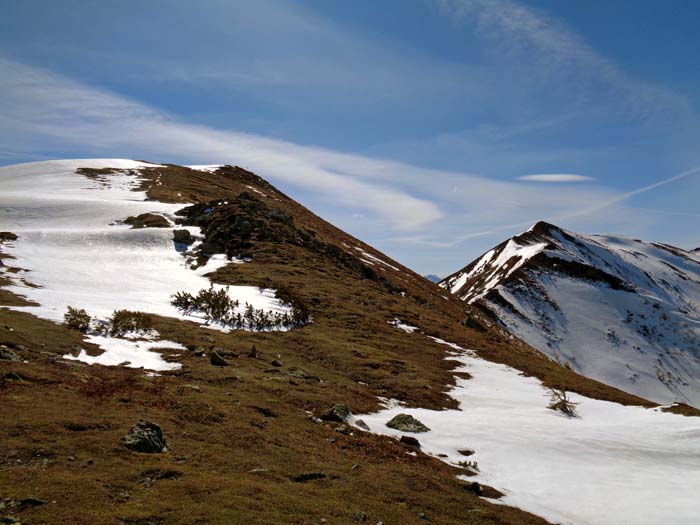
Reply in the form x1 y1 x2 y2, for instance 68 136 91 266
434 0 692 125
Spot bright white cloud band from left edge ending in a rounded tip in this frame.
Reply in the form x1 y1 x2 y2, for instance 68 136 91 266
0 56 442 231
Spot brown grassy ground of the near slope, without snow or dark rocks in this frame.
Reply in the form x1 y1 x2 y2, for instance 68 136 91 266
0 163 664 524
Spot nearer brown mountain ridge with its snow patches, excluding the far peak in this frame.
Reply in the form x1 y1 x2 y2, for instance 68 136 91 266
0 159 694 524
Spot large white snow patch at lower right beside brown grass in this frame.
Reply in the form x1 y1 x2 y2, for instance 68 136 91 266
353 339 700 525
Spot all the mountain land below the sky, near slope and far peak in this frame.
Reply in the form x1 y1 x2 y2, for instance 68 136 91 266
0 159 700 525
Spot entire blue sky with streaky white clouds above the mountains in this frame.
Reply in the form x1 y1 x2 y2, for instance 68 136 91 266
0 0 700 276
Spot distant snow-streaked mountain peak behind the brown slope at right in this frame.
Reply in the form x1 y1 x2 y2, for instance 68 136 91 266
440 222 700 406
